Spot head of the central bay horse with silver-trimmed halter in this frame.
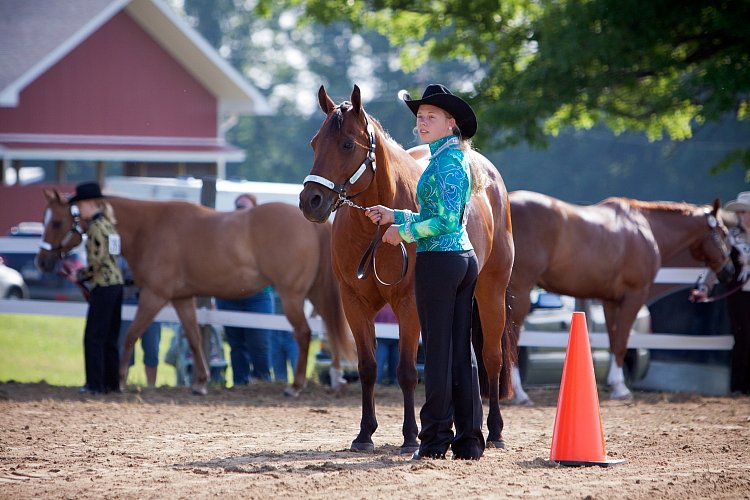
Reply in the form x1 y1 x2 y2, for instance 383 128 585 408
299 85 376 222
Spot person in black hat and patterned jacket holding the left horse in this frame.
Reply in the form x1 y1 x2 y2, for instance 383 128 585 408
68 182 123 394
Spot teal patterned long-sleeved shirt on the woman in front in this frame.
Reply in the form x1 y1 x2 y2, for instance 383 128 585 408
394 135 473 252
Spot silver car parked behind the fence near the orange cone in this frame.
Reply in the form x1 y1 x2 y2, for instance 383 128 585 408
518 290 651 384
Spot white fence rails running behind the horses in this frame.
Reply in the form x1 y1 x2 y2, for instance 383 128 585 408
0 237 734 350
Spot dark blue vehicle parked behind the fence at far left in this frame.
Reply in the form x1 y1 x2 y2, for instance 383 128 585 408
0 222 86 301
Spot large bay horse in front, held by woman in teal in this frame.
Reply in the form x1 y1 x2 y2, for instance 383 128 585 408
300 85 515 453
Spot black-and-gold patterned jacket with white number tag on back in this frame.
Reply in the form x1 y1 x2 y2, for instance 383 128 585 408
79 213 123 286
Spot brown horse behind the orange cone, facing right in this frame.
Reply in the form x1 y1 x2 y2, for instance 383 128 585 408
506 191 733 399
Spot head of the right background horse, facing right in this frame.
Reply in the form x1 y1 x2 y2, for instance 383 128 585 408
690 198 734 283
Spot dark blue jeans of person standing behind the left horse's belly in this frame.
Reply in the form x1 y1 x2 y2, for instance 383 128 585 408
216 288 274 385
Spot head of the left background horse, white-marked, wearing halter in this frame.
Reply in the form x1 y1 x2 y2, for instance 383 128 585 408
35 190 83 272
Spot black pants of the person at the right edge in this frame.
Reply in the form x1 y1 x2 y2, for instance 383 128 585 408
727 292 750 394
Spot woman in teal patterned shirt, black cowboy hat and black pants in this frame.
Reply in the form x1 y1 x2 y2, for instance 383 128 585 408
366 84 485 460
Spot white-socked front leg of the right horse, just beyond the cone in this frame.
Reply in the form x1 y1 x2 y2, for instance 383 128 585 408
602 294 645 400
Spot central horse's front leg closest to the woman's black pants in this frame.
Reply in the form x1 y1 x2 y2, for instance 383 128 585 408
394 295 420 454
